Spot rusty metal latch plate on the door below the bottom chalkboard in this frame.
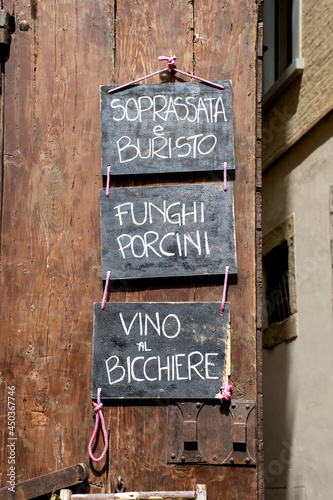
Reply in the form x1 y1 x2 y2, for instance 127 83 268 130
167 400 256 466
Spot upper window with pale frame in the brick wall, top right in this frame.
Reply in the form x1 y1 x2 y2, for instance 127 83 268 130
263 0 304 106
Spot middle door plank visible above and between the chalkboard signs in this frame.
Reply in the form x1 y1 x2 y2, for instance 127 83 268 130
109 0 194 301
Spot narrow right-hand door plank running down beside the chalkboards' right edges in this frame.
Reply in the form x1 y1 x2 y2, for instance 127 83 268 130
195 1 256 398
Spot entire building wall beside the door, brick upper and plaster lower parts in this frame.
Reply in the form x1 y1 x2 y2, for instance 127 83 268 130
262 0 333 500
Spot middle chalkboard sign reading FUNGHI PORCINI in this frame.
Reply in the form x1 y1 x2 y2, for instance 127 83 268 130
100 183 237 280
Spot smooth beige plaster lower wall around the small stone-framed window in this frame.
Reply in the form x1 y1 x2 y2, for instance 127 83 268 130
263 112 333 500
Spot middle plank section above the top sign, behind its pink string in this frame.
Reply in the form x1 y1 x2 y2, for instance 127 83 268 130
115 0 193 84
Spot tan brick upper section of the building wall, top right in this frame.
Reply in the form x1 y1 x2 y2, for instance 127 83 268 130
262 0 333 168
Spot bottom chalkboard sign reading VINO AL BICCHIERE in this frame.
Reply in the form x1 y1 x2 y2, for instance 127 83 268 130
92 302 230 399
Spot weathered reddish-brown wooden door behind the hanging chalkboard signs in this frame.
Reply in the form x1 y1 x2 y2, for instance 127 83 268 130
0 0 260 499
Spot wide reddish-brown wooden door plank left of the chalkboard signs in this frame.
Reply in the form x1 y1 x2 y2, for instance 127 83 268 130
1 1 113 483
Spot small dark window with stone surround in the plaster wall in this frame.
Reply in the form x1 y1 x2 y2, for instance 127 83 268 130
263 215 297 348
